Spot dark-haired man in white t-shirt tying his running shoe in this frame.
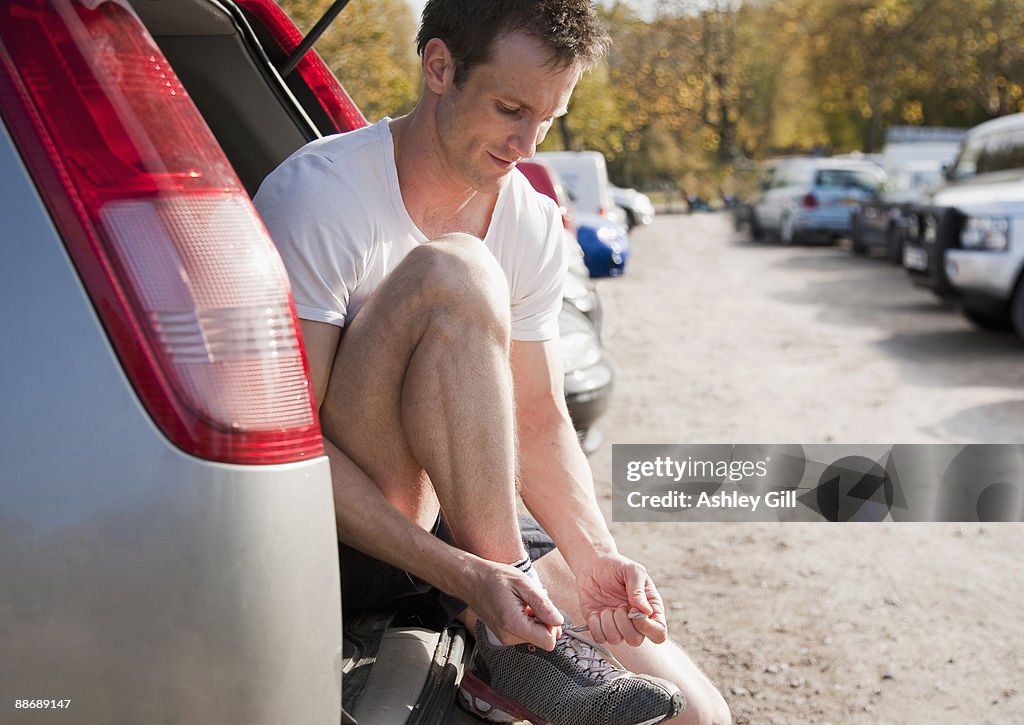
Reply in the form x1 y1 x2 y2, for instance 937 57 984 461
256 0 729 725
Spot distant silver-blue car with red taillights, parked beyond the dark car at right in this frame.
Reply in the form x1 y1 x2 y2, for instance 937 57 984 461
749 158 886 244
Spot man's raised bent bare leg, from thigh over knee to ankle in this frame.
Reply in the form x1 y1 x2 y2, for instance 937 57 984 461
321 234 524 593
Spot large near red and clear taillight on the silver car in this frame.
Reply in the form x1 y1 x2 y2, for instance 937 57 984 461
0 0 323 464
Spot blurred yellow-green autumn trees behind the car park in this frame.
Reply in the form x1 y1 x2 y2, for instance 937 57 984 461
283 0 1024 186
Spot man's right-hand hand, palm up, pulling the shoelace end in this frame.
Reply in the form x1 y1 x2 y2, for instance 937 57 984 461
575 554 669 647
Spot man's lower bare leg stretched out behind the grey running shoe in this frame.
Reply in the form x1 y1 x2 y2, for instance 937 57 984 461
535 550 732 725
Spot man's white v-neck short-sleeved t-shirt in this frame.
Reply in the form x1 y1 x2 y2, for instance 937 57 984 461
253 119 567 340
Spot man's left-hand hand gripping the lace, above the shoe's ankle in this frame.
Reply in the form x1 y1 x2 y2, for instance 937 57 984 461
460 559 564 651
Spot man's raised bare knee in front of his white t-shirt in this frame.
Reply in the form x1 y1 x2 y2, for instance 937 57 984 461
402 233 511 338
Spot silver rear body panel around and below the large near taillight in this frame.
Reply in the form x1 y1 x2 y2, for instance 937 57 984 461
0 55 341 725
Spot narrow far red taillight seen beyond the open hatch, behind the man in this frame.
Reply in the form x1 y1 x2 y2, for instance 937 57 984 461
237 0 367 131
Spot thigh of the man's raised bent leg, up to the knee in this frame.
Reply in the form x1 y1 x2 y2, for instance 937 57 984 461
321 234 508 516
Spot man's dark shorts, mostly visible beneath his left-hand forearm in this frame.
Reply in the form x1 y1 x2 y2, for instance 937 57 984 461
338 515 555 630
